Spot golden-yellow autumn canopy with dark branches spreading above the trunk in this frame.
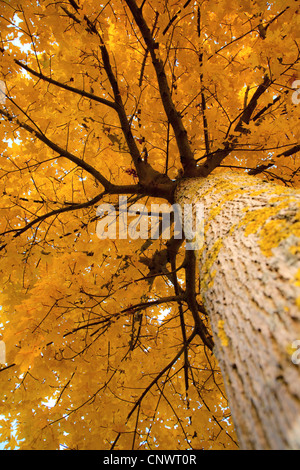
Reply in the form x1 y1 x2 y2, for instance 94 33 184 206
0 0 300 449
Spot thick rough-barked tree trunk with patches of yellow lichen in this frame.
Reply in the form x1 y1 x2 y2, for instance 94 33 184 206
175 173 300 449
